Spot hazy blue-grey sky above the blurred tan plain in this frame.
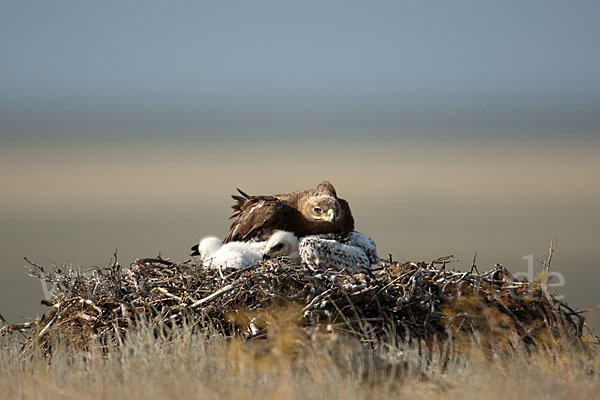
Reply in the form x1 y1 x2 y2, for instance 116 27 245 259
0 0 600 139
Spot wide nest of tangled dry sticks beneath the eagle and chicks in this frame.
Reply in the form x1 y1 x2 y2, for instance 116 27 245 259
2 255 589 351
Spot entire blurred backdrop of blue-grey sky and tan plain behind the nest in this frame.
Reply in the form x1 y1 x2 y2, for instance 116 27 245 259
0 0 600 326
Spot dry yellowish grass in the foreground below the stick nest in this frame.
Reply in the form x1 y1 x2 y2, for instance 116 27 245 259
0 327 600 400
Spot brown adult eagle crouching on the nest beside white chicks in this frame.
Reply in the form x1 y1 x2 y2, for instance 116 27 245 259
224 181 354 243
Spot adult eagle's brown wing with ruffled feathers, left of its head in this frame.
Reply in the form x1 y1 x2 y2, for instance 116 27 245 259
223 189 287 243
